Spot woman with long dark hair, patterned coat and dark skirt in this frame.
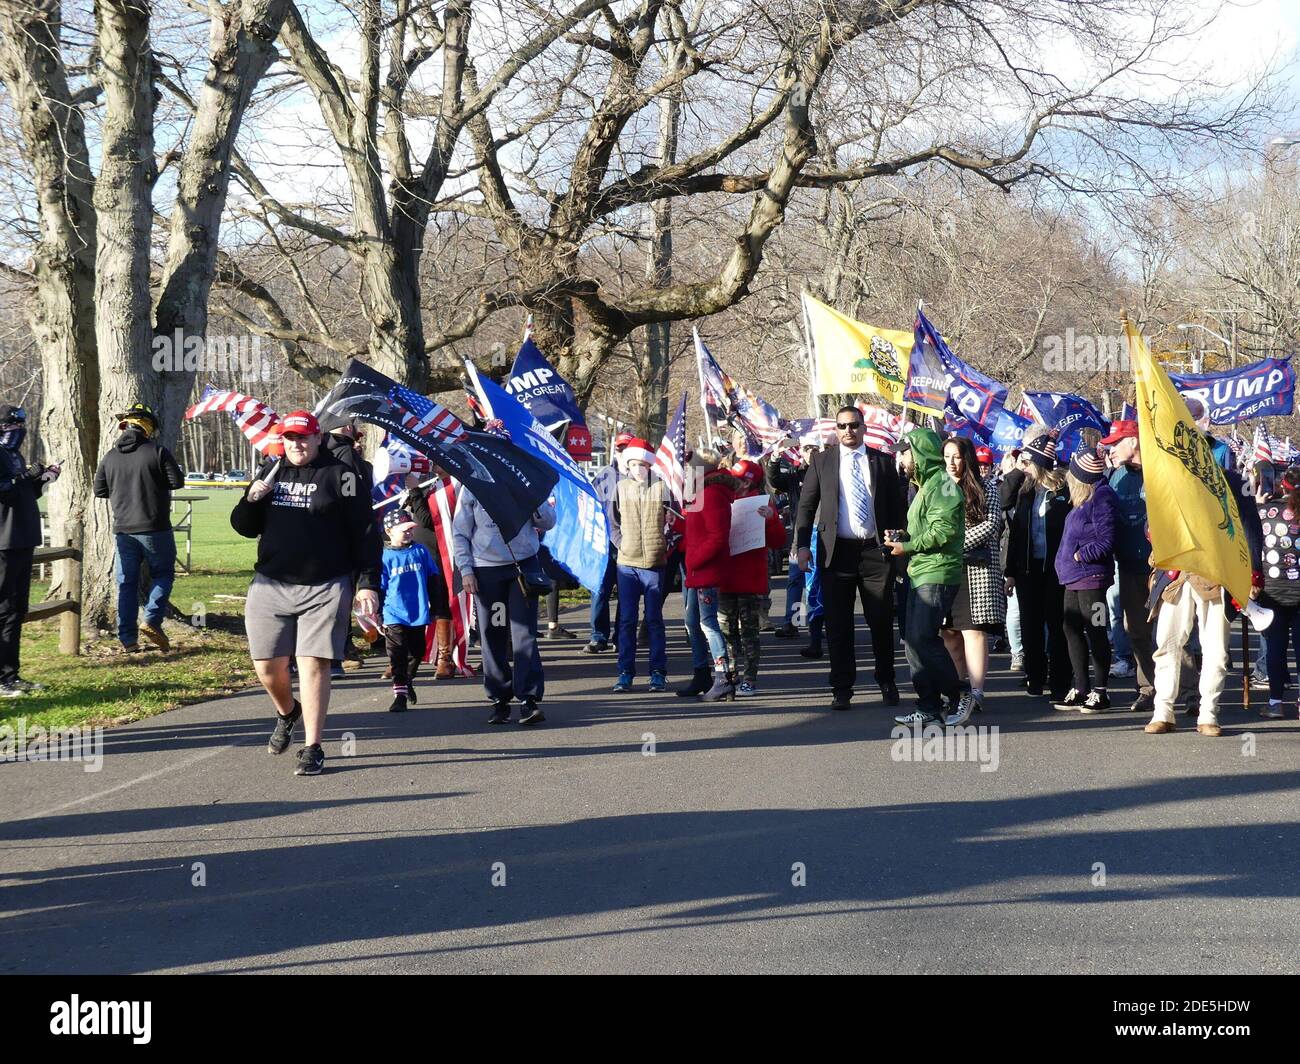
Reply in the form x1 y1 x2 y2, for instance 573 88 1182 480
943 436 1006 725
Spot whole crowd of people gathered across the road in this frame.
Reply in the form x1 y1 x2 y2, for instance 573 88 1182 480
0 399 1300 775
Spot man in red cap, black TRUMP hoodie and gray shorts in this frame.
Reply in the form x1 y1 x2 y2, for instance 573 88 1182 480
230 410 382 775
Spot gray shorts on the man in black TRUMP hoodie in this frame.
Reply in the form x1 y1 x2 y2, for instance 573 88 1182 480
244 572 352 661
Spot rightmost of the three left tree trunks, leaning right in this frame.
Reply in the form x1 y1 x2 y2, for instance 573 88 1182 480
155 0 287 446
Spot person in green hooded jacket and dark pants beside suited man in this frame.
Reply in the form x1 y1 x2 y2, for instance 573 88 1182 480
889 428 966 726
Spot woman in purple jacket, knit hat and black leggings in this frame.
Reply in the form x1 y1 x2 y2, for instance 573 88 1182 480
1056 447 1119 713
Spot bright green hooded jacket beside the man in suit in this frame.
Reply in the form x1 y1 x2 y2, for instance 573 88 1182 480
907 428 966 585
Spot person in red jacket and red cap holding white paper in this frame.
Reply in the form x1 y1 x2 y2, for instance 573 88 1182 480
718 459 785 698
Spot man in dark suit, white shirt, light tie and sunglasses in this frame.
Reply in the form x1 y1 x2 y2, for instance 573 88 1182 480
794 406 907 709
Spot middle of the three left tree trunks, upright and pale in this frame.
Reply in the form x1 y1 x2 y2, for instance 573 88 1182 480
82 0 163 624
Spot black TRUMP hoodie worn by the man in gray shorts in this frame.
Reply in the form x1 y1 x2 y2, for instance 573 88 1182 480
230 447 384 591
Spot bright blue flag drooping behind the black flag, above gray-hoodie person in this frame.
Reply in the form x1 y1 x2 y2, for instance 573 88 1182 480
465 359 610 591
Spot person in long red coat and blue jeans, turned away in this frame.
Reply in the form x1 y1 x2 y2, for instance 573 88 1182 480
684 450 736 702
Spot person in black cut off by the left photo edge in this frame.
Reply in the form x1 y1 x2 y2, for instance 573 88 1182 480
0 403 59 698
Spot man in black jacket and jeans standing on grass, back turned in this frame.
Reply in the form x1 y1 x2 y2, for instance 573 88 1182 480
95 403 185 654
